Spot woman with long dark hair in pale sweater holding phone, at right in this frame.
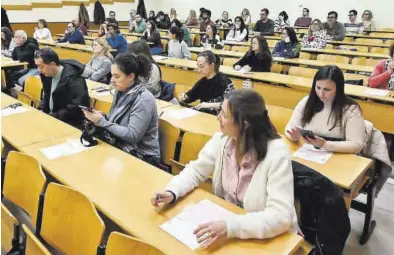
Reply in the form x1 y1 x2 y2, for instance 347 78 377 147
285 66 365 154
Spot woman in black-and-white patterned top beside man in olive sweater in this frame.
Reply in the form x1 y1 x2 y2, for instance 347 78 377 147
302 19 327 49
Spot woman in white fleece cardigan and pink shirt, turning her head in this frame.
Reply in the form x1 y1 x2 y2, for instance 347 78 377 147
151 89 297 248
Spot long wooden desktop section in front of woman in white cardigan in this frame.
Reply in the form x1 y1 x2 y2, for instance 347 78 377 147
22 135 302 255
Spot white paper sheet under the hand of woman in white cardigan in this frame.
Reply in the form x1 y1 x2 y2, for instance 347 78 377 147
160 199 236 250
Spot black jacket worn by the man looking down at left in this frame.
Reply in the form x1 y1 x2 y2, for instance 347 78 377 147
39 60 90 127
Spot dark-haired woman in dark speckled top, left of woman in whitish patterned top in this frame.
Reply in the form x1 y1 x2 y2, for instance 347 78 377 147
272 27 301 58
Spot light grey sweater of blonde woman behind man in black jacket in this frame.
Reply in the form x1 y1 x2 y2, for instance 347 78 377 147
82 56 112 82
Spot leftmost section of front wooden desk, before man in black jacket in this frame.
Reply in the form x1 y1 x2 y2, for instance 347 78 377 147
1 93 76 149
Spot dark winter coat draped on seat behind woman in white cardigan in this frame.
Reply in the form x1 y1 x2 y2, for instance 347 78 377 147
292 161 350 255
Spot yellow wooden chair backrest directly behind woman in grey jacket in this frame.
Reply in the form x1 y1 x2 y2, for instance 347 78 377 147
159 119 181 165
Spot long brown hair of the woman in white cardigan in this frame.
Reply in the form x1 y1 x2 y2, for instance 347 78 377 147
225 89 280 161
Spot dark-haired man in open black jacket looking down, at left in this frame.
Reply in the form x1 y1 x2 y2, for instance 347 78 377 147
35 48 89 127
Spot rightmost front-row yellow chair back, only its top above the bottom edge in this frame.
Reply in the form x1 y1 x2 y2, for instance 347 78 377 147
105 232 165 255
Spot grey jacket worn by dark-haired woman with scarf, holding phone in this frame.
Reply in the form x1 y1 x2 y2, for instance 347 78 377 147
97 86 160 160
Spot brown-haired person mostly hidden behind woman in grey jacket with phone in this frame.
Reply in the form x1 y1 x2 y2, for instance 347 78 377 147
128 40 161 98
